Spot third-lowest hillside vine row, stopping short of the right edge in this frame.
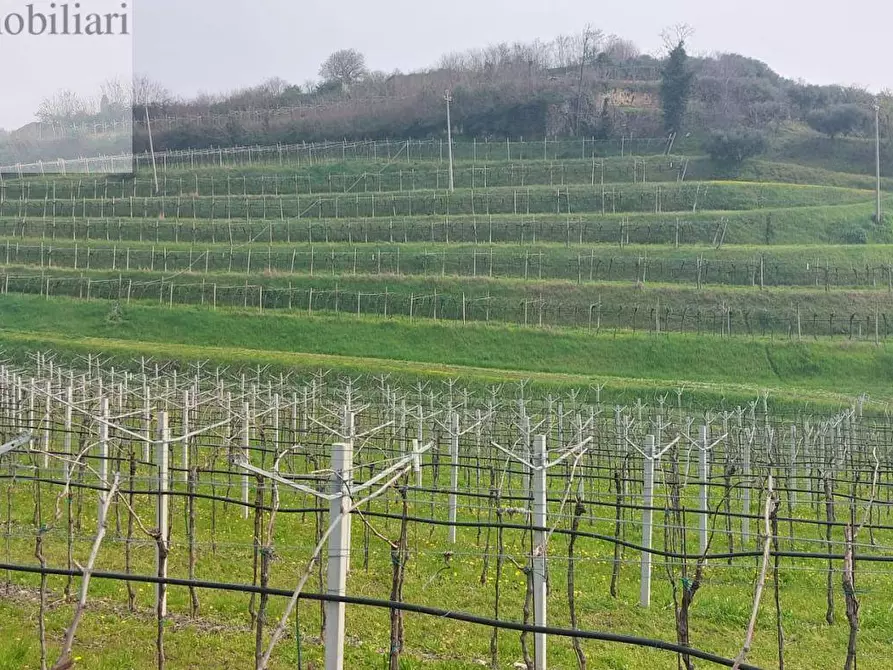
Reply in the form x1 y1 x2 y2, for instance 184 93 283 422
0 215 771 247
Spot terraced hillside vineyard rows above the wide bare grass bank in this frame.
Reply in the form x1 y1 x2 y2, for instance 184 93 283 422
0 139 893 342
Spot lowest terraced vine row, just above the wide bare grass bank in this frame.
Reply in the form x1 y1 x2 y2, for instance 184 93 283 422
6 272 893 343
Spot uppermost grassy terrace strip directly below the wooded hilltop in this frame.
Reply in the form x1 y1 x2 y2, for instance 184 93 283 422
5 152 893 193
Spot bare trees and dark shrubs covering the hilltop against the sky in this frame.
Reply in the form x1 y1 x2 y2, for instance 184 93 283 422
8 25 893 163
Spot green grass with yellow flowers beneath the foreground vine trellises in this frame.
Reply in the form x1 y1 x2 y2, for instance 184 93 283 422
0 454 893 670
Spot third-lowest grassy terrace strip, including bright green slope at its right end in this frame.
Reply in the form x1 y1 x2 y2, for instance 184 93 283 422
0 192 893 245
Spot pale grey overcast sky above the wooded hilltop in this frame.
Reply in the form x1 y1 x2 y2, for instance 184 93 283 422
0 0 893 128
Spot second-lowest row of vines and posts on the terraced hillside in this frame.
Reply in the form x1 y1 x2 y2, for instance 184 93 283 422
0 240 893 291
